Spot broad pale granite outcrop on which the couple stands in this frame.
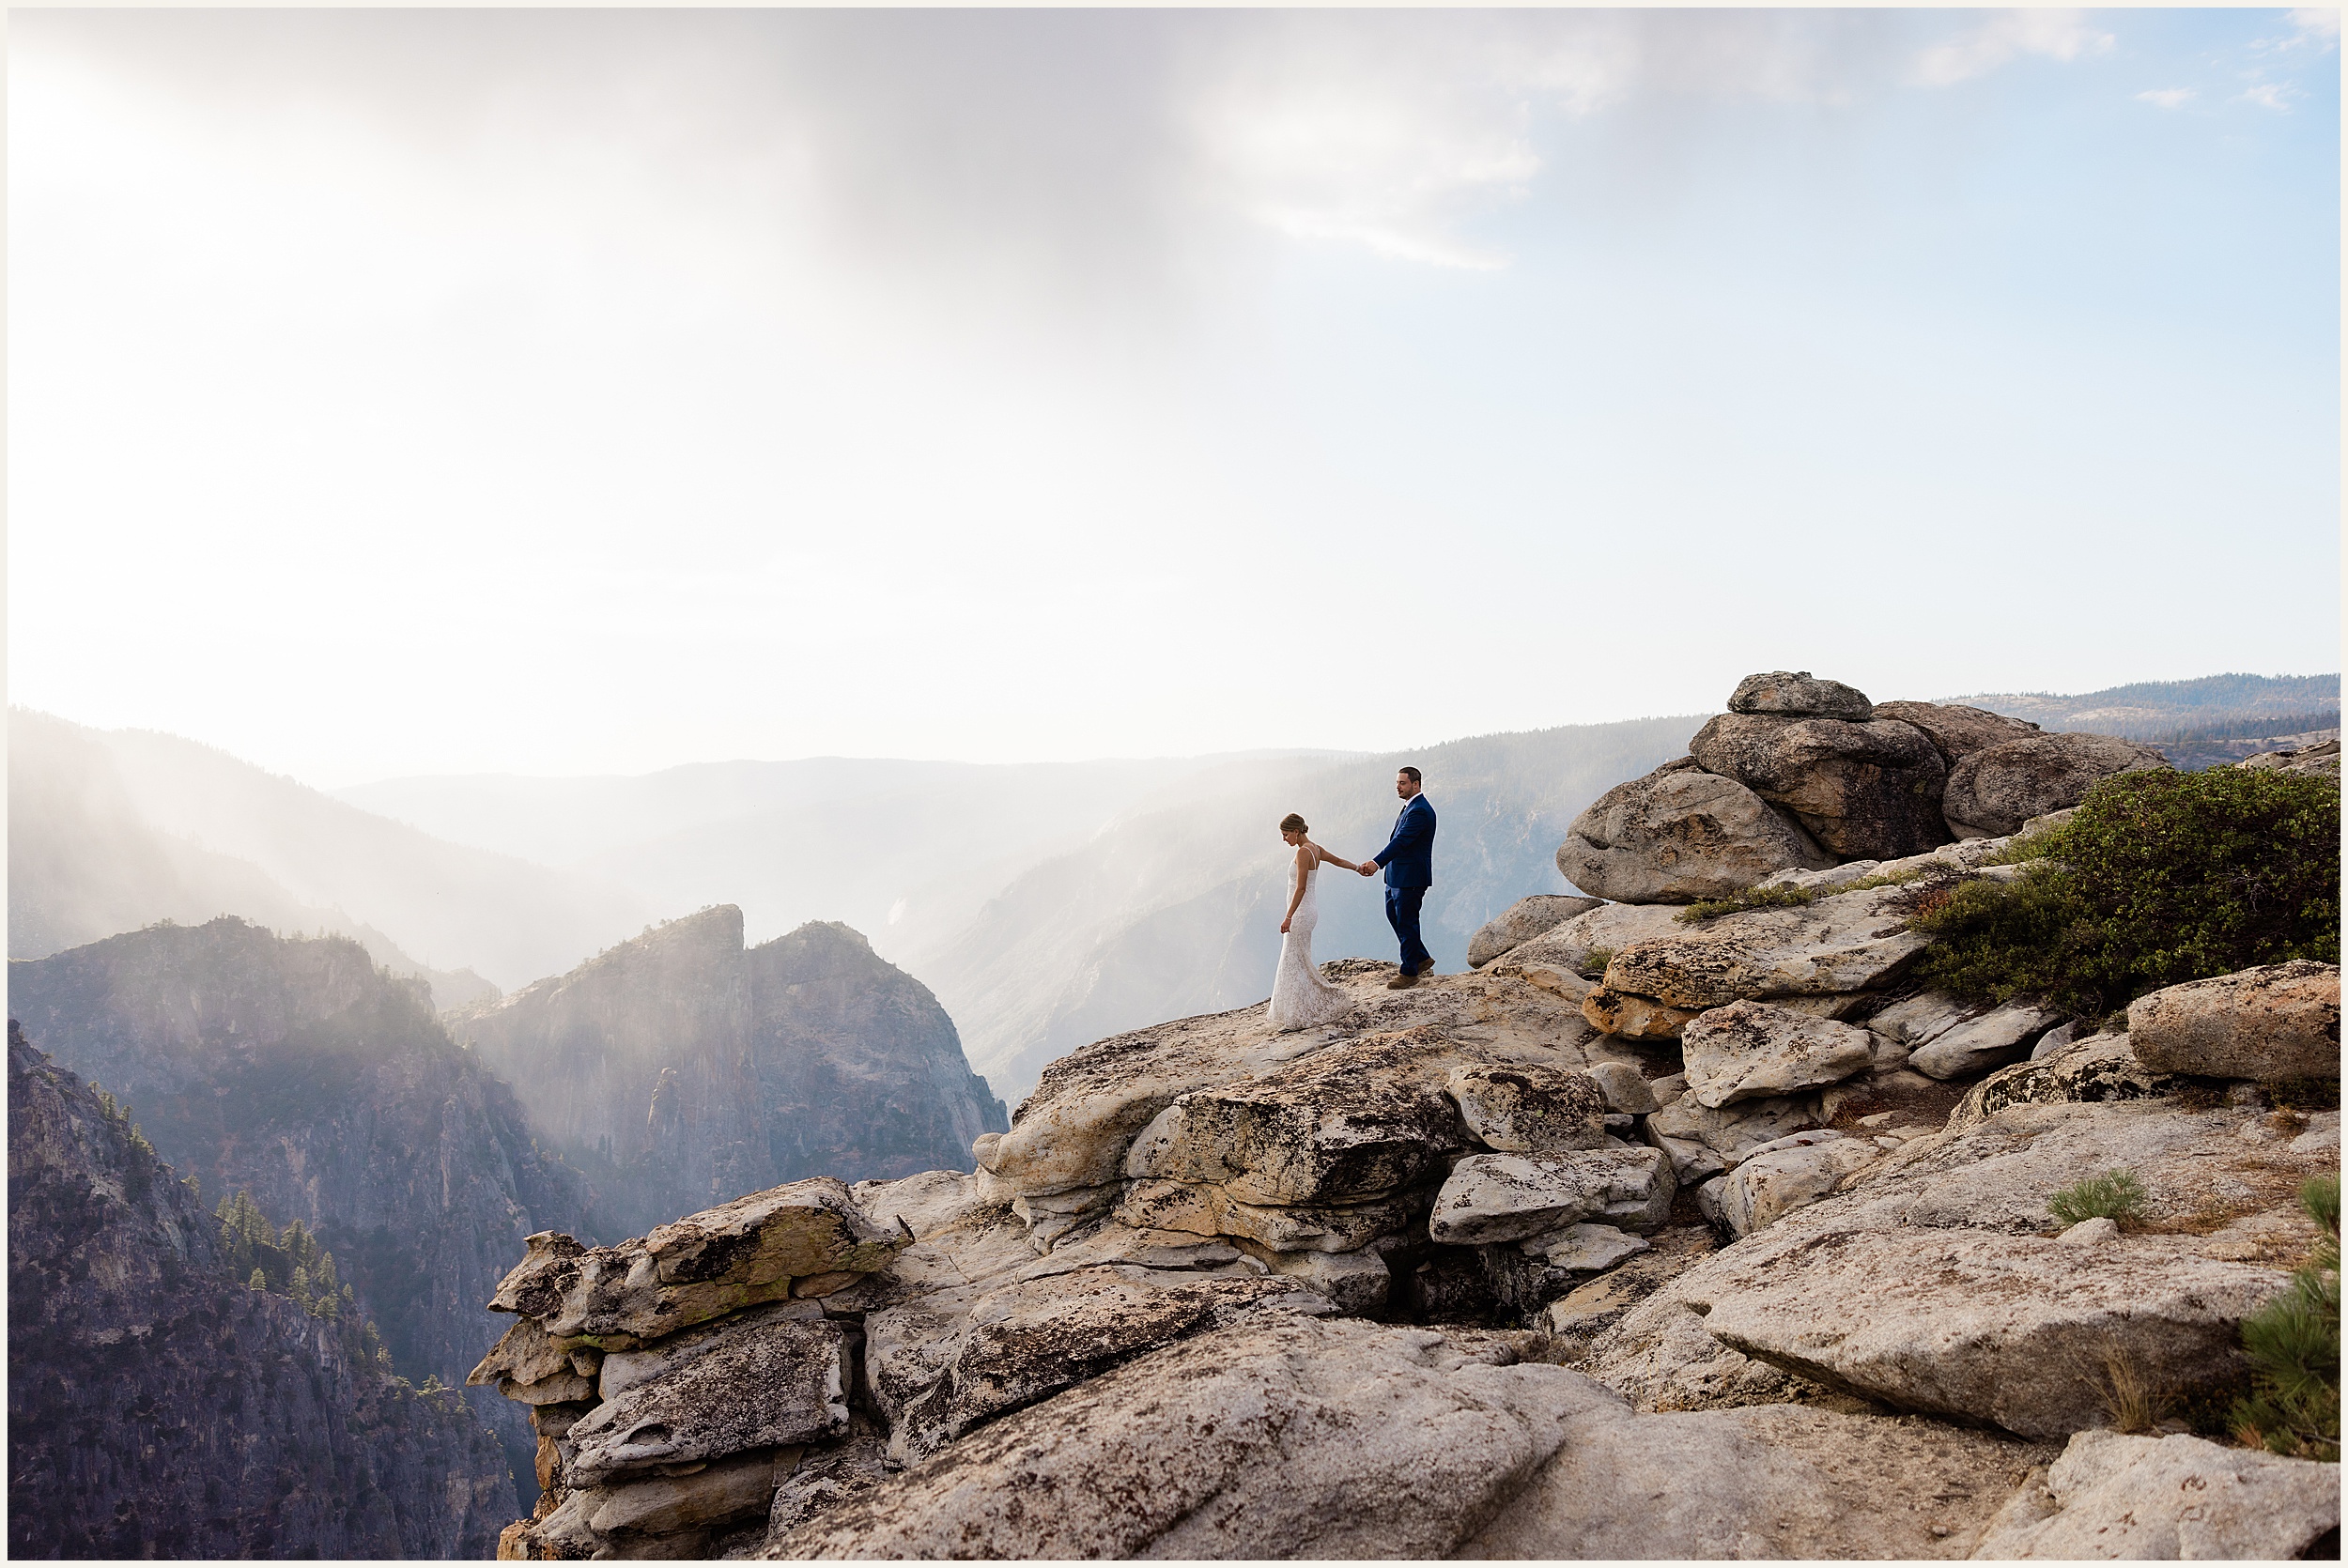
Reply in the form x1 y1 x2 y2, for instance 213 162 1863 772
477 676 2339 1559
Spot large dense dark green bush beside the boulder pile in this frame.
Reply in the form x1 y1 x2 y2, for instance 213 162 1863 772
1911 768 2341 1019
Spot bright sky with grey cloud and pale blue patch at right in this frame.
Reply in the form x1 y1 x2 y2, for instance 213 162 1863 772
8 9 2341 789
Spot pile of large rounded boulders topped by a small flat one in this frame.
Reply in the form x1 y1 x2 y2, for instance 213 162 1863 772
1557 671 2168 904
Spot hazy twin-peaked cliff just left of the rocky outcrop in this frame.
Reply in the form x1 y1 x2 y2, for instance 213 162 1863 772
451 906 1008 1233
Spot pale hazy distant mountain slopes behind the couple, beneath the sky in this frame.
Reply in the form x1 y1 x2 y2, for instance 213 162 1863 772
9 676 2339 1103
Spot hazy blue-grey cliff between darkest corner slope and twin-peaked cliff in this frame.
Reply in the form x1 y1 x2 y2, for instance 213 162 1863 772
9 918 599 1474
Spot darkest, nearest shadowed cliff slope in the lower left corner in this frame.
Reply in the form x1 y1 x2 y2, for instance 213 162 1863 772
8 1022 515 1559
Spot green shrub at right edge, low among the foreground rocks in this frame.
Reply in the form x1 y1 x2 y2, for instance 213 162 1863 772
2233 1174 2341 1463
